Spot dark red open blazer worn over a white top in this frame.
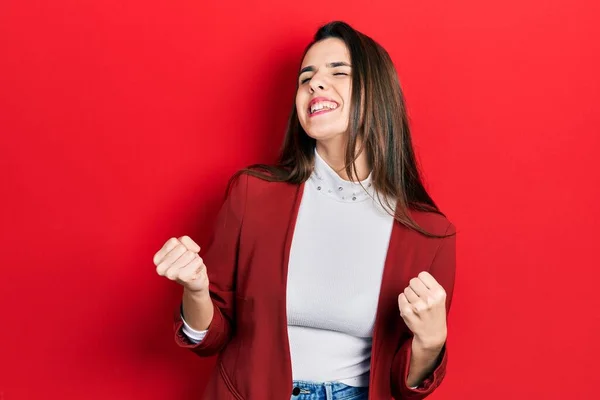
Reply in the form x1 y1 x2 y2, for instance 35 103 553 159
174 175 456 400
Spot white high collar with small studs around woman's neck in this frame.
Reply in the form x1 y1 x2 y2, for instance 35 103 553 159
309 148 375 203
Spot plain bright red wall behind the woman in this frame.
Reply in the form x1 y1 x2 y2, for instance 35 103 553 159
0 0 600 400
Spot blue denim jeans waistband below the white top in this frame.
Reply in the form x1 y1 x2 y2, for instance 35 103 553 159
290 381 369 400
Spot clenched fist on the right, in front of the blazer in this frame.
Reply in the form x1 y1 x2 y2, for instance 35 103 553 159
398 271 448 349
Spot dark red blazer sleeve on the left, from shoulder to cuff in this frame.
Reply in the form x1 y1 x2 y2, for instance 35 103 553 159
174 174 248 356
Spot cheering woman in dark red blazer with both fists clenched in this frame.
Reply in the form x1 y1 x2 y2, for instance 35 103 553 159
154 22 455 400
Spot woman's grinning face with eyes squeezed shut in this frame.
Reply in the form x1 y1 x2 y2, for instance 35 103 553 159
296 38 352 140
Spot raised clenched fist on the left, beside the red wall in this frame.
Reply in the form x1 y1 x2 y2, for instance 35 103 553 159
154 236 208 293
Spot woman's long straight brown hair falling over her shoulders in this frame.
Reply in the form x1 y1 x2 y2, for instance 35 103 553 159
230 21 444 237
